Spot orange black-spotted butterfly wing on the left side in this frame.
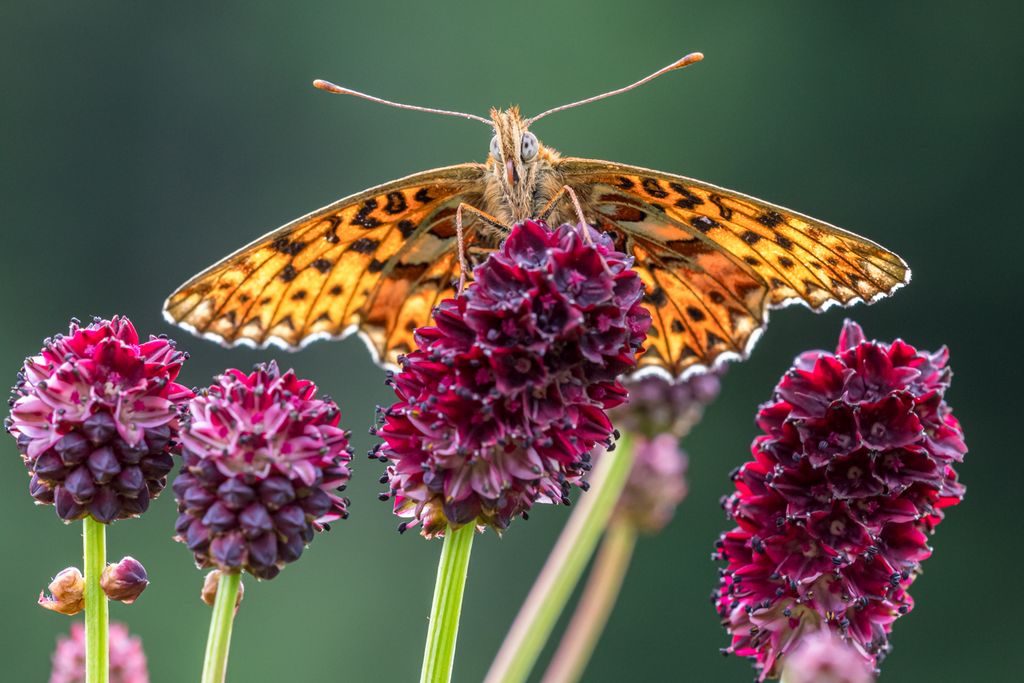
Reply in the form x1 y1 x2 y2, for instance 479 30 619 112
164 164 493 365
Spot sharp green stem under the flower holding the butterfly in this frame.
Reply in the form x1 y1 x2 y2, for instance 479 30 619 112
420 522 476 683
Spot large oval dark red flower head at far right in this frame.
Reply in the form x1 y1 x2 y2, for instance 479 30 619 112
716 321 967 679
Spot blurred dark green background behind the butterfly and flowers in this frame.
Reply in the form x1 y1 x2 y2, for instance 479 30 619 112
0 0 1024 683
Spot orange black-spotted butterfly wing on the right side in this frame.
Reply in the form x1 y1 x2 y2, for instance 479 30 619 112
557 158 910 377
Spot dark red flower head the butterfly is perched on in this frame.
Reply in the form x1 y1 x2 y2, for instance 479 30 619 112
372 221 650 537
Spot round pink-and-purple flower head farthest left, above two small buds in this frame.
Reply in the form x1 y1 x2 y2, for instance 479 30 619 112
5 316 191 522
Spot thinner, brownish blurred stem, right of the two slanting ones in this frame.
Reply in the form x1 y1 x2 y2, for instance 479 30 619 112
541 522 637 683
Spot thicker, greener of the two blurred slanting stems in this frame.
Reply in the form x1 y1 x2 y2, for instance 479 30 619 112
485 434 633 683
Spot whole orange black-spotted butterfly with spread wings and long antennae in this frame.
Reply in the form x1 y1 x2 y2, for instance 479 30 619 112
164 52 910 377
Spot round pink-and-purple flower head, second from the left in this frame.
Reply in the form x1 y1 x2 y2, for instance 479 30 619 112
173 361 352 579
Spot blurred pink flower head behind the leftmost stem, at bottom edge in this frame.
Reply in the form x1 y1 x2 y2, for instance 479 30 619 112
50 622 150 683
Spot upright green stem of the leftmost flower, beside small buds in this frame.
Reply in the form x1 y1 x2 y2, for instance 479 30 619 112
82 515 111 683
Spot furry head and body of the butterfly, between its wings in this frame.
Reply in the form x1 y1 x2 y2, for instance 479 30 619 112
480 106 563 225
